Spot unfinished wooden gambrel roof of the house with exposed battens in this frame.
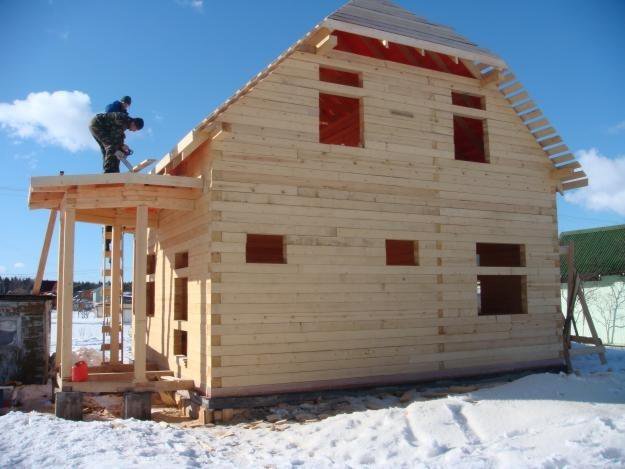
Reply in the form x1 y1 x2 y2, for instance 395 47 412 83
154 0 588 192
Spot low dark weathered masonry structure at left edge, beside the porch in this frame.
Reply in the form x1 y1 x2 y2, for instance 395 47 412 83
0 295 52 384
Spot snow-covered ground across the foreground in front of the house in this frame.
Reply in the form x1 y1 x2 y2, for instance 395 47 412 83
0 349 625 468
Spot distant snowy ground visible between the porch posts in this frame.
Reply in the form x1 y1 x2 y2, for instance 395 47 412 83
50 310 132 364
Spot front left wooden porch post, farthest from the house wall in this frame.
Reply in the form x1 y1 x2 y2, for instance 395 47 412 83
61 208 76 380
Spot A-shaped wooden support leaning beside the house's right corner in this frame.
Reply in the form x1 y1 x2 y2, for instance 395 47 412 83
560 242 607 372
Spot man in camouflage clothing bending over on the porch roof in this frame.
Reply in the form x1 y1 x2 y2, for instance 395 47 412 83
89 112 143 173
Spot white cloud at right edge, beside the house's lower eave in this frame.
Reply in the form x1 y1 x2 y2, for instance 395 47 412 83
564 148 625 216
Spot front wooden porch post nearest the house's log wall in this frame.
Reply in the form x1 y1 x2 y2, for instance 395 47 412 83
132 206 148 383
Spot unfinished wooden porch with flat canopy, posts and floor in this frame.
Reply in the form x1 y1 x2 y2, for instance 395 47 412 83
28 173 204 392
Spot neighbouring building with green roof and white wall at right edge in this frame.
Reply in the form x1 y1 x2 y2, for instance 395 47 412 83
560 225 625 345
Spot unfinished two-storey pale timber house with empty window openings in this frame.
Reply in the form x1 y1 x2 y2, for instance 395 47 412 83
30 0 587 398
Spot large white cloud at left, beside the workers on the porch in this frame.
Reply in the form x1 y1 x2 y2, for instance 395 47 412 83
0 91 98 152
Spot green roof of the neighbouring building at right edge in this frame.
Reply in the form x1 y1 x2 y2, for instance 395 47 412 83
560 225 625 278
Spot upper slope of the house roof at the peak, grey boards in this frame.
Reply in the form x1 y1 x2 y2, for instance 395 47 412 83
323 0 505 67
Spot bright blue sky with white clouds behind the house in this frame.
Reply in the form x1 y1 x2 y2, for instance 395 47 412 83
0 0 625 280
